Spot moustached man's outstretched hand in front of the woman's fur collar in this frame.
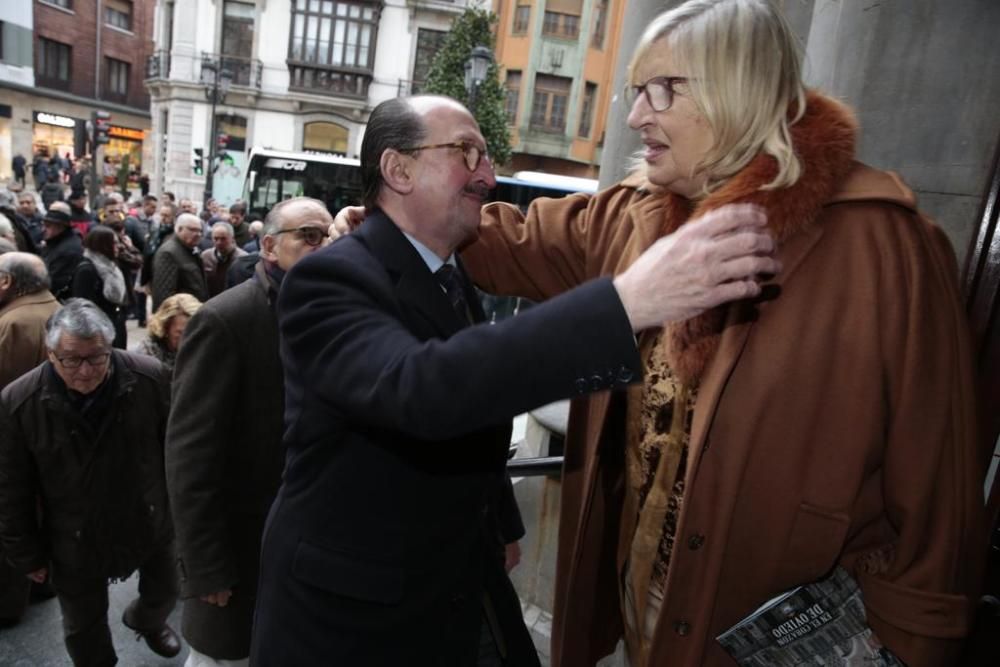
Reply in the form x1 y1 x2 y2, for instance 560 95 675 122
614 204 781 331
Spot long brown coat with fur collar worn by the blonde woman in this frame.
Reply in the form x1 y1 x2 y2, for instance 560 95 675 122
463 91 987 667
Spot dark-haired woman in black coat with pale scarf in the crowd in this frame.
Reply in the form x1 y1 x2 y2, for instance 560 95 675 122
72 225 129 350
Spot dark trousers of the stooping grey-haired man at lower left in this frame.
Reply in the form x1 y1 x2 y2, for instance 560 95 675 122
52 544 179 667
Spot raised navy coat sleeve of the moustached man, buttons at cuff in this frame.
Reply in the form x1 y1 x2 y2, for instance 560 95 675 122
278 244 640 440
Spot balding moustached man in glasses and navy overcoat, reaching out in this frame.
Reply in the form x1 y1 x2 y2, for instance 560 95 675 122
251 97 774 667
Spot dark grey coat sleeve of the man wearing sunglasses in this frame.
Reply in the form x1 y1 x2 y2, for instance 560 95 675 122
166 307 242 597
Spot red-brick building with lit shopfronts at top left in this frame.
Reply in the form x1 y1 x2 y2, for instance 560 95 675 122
0 0 155 187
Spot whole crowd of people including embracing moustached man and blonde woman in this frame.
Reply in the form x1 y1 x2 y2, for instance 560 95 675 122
0 0 987 667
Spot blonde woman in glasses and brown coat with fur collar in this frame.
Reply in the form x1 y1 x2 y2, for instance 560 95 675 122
463 0 986 667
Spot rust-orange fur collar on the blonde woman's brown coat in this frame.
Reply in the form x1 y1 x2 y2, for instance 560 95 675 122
662 92 857 384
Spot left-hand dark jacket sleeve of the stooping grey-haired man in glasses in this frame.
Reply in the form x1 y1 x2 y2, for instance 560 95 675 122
0 401 48 574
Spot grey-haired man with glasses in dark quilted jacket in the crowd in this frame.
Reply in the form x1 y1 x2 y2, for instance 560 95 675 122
152 213 208 310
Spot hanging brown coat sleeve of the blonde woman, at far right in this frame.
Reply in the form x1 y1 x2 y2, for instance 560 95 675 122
856 211 989 667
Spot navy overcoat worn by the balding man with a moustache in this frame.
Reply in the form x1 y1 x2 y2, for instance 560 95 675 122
251 212 640 667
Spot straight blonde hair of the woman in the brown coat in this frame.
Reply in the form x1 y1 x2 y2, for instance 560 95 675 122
628 0 805 191
